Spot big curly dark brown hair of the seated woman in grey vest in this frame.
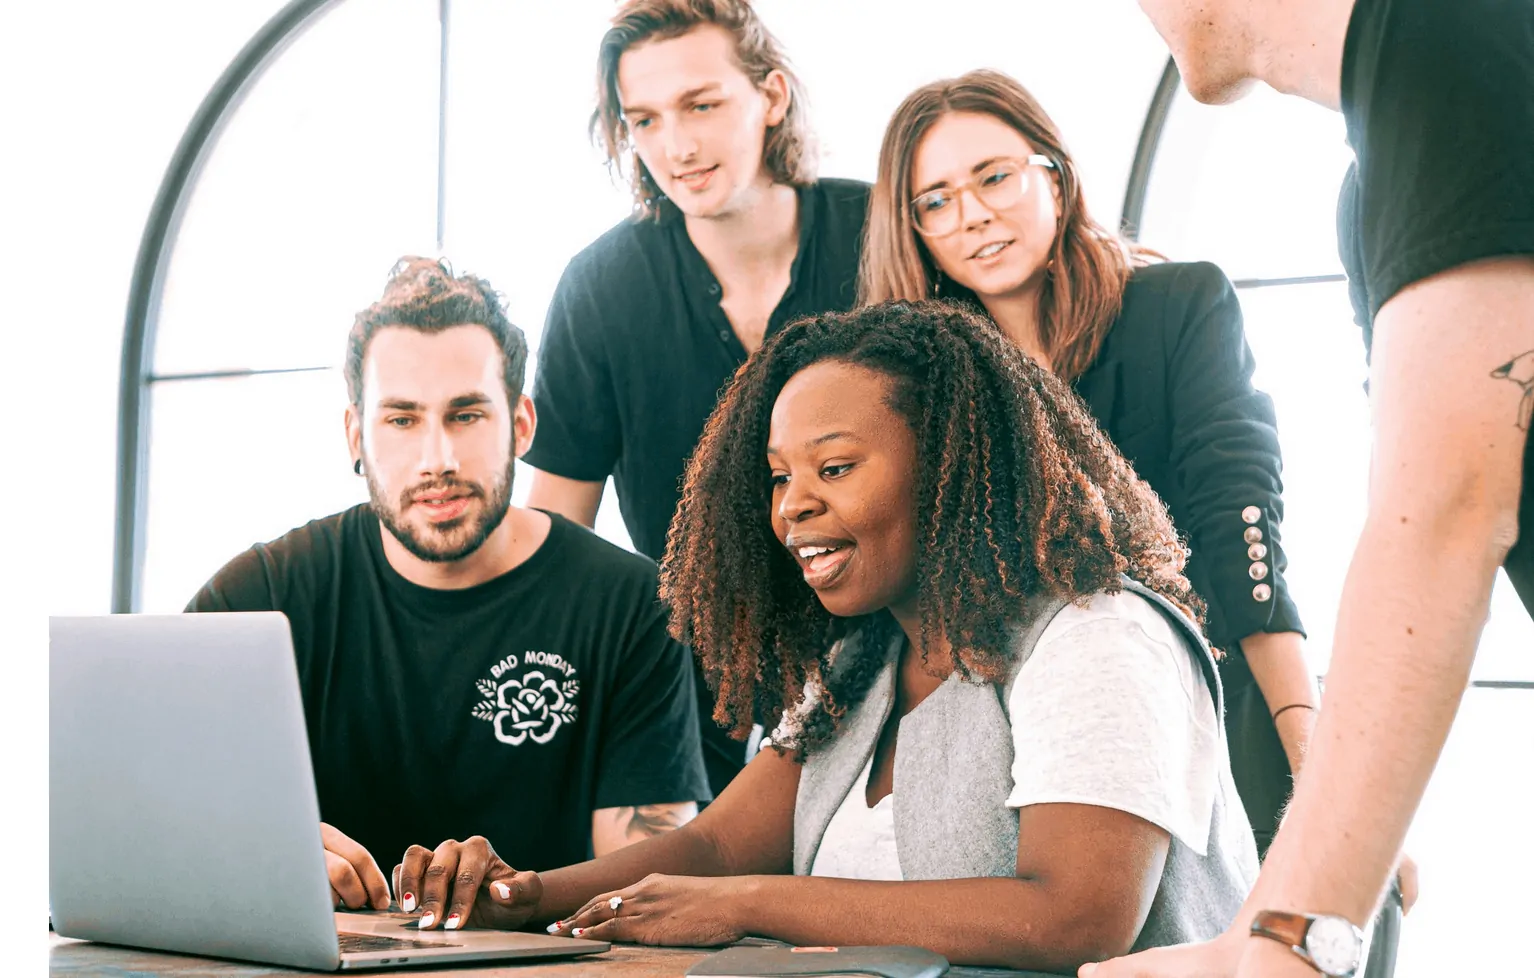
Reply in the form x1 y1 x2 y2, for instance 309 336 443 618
661 300 1203 753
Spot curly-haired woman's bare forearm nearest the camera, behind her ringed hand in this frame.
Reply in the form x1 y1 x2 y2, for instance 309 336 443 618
730 877 1144 973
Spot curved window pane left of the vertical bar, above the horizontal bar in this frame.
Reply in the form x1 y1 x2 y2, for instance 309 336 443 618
155 0 440 374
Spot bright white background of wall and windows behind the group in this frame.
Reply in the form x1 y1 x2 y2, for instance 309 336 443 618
0 0 1534 978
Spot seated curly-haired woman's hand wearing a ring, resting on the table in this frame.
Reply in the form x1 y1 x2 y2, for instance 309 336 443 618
549 874 746 947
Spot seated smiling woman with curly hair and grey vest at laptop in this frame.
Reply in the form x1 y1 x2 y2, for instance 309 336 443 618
396 302 1256 972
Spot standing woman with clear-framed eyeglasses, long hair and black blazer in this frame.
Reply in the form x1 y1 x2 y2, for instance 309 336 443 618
859 71 1316 852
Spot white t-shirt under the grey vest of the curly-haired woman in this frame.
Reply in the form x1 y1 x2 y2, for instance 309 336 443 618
811 592 1221 880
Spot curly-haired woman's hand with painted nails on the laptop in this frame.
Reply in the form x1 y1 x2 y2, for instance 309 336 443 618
394 835 543 930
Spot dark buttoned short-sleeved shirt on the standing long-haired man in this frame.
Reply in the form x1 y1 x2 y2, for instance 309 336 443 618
523 179 868 794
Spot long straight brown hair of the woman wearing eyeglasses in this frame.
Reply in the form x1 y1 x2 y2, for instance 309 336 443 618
858 71 1160 380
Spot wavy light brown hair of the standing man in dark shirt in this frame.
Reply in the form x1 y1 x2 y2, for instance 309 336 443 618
591 0 816 218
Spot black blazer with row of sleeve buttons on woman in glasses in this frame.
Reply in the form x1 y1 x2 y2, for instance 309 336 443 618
1075 262 1304 659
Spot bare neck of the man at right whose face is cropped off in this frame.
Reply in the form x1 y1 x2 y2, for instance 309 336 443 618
1246 0 1355 110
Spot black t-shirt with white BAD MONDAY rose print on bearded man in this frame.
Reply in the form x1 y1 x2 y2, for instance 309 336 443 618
187 504 709 874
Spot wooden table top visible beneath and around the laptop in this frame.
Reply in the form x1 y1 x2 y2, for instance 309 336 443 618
48 934 1054 978
